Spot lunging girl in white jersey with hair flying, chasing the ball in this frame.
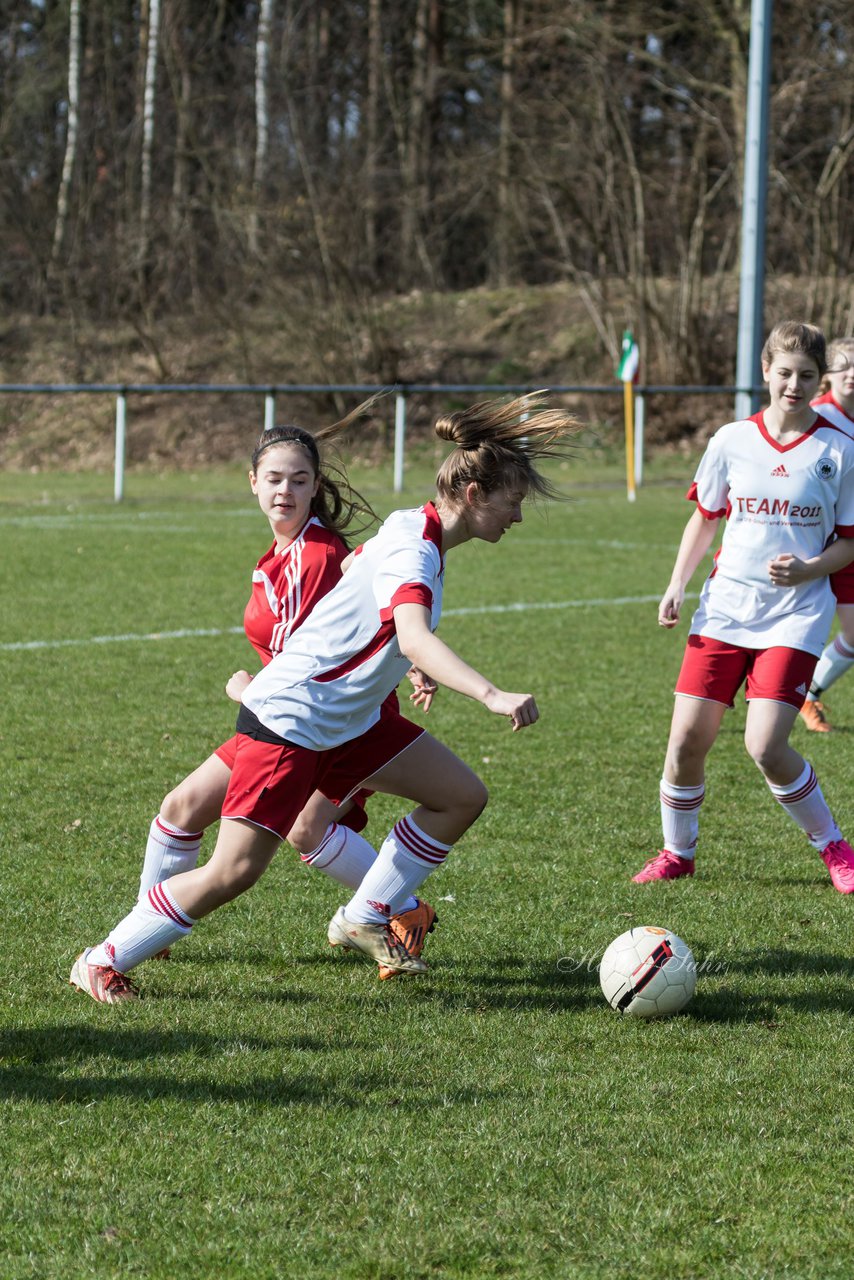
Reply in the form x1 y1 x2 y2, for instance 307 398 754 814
72 397 577 1000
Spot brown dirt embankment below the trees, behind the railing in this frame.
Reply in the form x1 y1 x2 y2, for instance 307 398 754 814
0 285 747 470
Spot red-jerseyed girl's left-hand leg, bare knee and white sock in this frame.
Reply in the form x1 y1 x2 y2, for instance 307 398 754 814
140 755 232 897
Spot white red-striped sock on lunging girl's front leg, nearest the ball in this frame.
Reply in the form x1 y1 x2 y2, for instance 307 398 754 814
344 814 451 924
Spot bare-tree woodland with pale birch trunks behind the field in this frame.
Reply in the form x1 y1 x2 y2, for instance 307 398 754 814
0 0 854 455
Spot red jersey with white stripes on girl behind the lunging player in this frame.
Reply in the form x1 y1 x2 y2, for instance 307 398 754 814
243 516 347 666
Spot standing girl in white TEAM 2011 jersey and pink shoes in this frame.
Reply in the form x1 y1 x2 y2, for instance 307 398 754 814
634 321 854 893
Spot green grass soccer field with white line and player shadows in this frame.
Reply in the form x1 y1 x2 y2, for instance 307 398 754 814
0 457 854 1280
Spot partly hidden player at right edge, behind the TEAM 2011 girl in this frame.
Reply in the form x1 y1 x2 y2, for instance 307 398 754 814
800 338 854 733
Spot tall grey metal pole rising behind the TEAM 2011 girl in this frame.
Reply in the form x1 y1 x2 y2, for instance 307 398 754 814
735 0 773 419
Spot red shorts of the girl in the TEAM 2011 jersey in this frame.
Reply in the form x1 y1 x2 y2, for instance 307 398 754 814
676 636 818 709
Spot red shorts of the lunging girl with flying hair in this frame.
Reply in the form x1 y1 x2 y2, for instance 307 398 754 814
216 710 424 840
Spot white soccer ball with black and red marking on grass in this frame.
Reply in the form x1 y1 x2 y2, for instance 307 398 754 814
599 924 697 1018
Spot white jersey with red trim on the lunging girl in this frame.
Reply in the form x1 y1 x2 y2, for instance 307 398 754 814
236 502 444 751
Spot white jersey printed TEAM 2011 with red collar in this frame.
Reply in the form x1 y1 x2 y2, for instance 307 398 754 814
688 412 854 654
